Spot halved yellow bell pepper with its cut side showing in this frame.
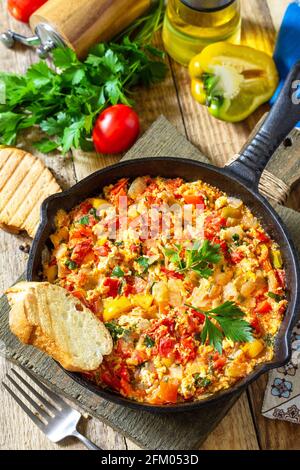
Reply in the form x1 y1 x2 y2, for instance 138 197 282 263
189 42 279 122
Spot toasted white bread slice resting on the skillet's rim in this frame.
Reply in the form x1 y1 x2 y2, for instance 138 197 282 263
6 282 113 372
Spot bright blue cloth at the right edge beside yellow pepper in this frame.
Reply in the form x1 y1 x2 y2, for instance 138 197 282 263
271 0 300 128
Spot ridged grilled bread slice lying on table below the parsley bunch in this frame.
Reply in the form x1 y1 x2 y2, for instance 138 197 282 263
0 148 61 237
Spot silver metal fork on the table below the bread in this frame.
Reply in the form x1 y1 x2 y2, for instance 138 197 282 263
2 367 102 450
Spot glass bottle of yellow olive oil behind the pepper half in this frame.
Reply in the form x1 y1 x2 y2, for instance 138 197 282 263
163 0 241 66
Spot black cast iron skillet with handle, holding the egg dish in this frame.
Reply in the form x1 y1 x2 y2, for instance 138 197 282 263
27 62 300 412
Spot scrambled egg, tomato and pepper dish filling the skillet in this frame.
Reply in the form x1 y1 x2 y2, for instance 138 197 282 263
44 176 287 404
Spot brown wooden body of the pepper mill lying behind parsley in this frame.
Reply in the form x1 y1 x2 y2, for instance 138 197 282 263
30 0 151 57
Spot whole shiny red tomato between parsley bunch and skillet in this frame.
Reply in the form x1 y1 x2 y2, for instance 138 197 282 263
93 104 140 154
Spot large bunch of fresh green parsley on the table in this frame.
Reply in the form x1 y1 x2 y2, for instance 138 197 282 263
0 1 166 153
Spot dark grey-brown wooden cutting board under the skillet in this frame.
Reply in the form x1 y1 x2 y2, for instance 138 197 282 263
0 117 300 450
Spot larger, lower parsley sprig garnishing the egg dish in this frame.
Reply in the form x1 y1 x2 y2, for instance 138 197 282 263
186 301 253 354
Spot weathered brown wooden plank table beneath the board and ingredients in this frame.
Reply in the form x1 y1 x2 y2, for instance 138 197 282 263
0 0 300 450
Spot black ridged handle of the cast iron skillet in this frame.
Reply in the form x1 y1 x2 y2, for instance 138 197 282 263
227 61 300 190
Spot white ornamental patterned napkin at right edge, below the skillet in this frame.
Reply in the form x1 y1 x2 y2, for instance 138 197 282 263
262 320 300 424
